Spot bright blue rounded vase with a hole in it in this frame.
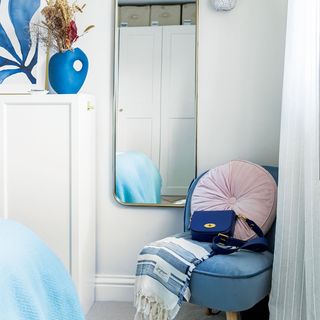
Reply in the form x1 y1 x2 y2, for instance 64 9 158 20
49 48 89 94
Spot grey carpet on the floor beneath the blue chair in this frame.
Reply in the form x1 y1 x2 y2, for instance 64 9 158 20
86 302 225 320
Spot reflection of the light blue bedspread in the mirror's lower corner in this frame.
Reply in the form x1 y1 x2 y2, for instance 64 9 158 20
116 151 162 203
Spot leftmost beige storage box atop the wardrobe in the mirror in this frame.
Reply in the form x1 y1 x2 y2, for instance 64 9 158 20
119 6 150 27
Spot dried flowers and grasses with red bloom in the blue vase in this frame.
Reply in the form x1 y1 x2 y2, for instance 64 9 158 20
36 0 94 52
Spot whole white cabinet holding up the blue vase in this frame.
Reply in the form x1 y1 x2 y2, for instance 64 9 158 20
0 95 96 313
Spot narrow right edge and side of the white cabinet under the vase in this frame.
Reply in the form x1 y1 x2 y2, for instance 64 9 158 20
72 96 96 314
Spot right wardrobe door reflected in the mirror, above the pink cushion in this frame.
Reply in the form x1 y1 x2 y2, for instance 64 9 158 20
160 26 196 195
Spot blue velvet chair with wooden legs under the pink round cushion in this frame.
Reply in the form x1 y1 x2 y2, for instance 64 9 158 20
183 167 278 320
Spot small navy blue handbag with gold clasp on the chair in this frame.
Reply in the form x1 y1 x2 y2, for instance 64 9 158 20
190 210 237 242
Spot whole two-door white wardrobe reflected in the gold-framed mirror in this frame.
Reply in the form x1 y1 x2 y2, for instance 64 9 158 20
117 26 196 195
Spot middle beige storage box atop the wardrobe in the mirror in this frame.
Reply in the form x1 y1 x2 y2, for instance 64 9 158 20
151 5 181 26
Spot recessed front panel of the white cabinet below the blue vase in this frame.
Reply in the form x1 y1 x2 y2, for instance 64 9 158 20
0 100 71 271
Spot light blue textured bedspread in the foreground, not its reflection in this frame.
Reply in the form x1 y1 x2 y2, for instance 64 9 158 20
0 220 84 320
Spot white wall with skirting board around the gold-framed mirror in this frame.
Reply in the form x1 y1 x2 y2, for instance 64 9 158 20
78 0 286 300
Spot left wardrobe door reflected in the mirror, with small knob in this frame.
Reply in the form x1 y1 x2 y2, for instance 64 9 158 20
117 27 162 167
